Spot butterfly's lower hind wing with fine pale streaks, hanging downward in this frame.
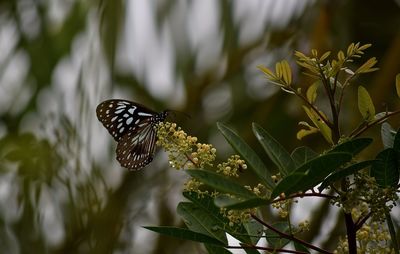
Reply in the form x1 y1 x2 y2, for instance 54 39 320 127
116 119 157 170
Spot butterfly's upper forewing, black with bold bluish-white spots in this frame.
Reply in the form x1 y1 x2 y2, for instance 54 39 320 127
96 100 157 141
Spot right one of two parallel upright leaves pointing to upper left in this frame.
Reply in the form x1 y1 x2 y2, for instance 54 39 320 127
253 123 295 176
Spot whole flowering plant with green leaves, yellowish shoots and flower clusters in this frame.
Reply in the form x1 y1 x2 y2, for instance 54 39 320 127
146 43 400 253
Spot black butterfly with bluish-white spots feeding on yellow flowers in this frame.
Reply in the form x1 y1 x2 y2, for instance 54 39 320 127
96 99 169 170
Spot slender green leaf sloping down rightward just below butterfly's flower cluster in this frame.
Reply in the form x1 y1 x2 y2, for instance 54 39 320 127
185 169 257 198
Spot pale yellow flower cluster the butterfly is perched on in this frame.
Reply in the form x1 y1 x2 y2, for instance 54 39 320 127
156 122 216 169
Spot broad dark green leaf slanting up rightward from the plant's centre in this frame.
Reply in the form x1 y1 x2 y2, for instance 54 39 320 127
271 153 352 199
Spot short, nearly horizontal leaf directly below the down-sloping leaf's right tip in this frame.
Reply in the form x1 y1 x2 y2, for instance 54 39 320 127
214 195 268 210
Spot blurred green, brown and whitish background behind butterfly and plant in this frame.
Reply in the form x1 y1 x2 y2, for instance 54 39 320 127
0 0 400 254
